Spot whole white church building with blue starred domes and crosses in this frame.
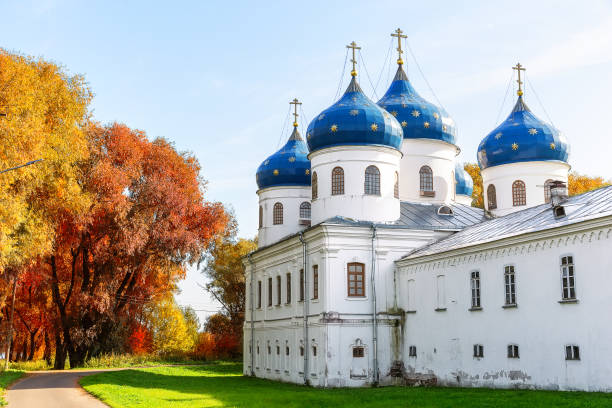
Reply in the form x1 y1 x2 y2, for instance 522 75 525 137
244 33 612 391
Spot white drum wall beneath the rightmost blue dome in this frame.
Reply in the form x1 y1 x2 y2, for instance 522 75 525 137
481 161 570 216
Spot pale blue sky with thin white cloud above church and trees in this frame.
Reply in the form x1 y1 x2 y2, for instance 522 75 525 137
0 0 612 324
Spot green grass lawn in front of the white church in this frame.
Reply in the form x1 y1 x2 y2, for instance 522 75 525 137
81 363 612 408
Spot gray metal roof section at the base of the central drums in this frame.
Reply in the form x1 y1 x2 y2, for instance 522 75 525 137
324 201 485 231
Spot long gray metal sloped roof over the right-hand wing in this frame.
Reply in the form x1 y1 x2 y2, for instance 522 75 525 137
402 186 612 259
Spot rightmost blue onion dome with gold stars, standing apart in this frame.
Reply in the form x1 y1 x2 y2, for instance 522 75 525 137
478 96 570 169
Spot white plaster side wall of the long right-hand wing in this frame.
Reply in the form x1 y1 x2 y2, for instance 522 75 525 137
398 224 612 392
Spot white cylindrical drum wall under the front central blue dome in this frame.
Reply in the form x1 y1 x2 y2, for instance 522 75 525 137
308 146 401 225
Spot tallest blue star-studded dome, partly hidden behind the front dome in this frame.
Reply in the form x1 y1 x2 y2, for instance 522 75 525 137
378 65 456 145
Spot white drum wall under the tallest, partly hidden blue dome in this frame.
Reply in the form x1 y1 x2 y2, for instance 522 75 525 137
400 139 459 203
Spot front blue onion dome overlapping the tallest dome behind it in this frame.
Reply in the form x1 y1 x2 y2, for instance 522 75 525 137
306 77 402 152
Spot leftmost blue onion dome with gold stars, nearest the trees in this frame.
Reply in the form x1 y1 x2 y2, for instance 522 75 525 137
255 127 310 190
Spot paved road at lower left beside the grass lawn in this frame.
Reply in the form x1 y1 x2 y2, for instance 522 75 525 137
6 370 118 408
